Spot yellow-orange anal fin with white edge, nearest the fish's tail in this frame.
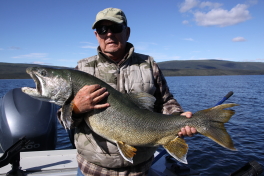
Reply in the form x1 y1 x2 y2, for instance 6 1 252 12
163 136 188 164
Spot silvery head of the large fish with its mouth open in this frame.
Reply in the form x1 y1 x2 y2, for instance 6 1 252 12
22 67 72 106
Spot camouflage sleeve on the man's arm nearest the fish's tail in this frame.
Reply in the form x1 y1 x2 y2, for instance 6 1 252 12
152 62 184 114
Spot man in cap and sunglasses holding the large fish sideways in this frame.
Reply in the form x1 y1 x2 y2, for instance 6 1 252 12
59 8 196 176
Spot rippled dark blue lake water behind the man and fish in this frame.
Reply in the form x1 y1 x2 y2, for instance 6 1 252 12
0 75 264 176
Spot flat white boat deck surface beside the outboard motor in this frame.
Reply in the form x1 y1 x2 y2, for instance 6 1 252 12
0 149 78 176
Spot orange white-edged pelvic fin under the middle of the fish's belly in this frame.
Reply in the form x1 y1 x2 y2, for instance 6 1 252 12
116 141 137 163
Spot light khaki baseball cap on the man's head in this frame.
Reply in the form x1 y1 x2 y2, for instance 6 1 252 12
92 8 127 29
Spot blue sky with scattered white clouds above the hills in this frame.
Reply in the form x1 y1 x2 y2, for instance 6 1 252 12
0 0 264 67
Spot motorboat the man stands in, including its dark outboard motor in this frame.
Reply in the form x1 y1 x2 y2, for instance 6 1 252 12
0 88 262 176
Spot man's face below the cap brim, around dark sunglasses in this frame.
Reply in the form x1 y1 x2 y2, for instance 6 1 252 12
94 20 130 60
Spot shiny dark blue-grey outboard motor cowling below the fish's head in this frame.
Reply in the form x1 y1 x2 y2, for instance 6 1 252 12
0 88 58 152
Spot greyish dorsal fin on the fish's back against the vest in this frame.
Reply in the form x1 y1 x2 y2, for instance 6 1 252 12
126 92 156 111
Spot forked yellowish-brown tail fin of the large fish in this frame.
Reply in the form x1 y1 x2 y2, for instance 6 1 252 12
194 103 238 150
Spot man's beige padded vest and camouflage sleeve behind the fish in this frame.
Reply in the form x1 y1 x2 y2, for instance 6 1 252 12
64 43 183 168
